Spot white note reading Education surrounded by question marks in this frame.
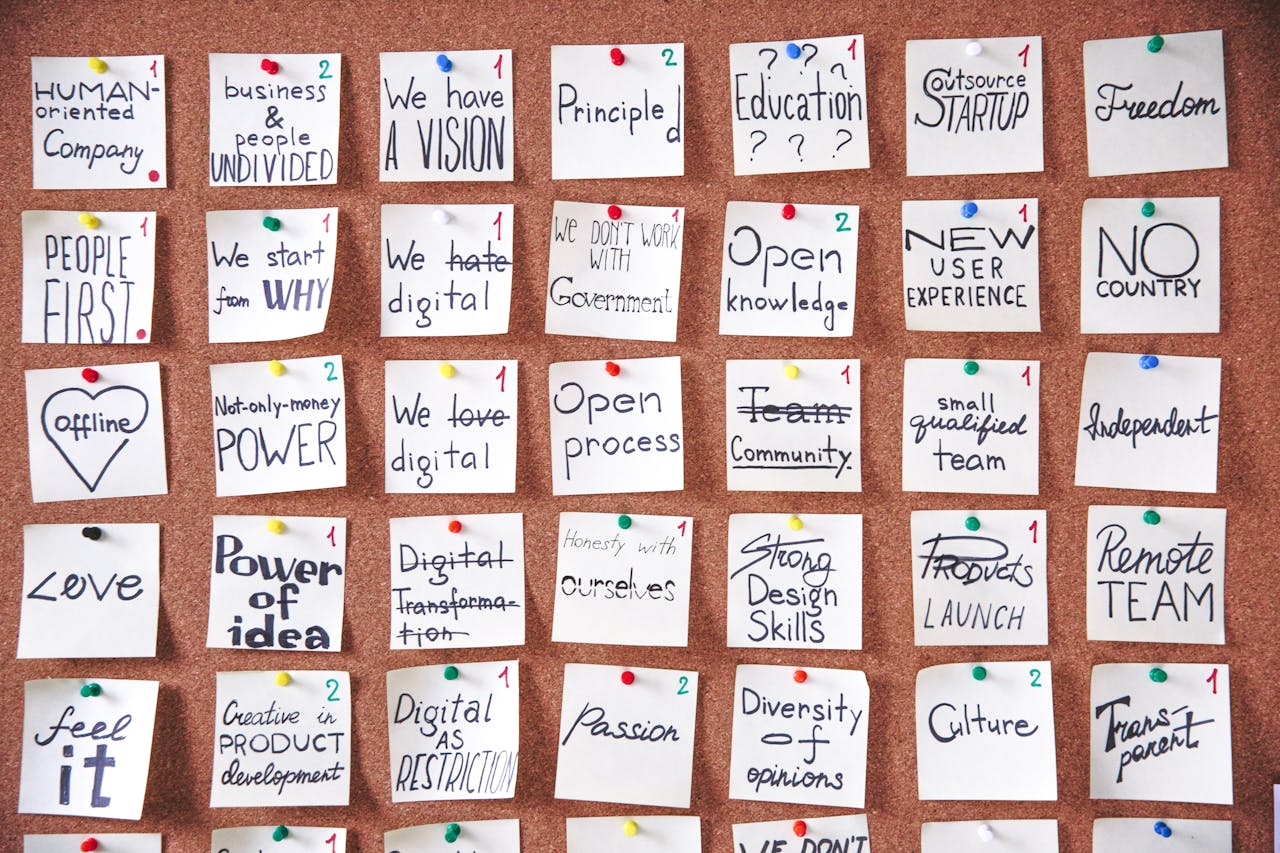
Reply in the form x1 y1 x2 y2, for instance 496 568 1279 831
728 35 872 174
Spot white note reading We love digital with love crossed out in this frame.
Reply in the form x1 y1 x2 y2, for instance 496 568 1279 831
385 361 520 494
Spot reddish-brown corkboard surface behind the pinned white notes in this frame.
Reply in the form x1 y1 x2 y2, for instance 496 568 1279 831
0 0 1280 853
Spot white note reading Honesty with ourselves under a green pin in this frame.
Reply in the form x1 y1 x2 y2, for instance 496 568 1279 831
552 512 694 647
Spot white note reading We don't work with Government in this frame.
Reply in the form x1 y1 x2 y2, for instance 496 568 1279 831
545 201 685 341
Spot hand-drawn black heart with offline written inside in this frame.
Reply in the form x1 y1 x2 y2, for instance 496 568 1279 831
40 386 151 492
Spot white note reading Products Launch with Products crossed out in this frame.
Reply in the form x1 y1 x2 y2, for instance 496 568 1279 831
911 510 1048 646
